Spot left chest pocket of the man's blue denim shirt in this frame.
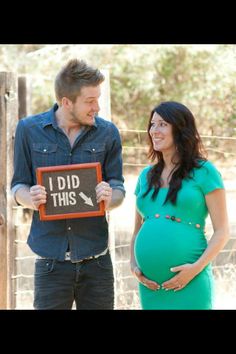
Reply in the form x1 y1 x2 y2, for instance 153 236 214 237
33 143 58 167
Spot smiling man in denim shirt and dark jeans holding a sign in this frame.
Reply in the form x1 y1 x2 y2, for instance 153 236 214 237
11 59 125 309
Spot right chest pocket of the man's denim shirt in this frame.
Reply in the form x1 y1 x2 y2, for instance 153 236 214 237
79 143 105 164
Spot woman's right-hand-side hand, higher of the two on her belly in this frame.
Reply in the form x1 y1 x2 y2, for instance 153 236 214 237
162 263 198 291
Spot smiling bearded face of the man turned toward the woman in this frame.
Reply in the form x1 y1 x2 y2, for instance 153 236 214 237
68 86 101 126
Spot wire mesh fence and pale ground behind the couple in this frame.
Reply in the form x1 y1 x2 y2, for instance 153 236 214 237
12 130 236 310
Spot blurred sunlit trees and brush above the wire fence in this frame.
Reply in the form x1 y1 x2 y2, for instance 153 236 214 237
0 44 236 137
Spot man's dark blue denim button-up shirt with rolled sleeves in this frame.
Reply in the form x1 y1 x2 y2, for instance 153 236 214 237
11 104 125 262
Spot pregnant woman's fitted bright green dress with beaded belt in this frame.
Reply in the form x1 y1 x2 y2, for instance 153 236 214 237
134 161 224 310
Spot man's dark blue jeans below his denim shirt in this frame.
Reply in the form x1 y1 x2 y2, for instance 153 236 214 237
34 252 114 310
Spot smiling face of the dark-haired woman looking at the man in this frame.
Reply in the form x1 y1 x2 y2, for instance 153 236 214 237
149 112 175 153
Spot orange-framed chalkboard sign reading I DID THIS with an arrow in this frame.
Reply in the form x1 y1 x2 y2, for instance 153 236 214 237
36 162 104 220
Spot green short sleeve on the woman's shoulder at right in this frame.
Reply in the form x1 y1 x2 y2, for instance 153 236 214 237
198 161 224 195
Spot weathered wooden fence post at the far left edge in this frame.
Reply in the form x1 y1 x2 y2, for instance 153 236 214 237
0 72 18 309
